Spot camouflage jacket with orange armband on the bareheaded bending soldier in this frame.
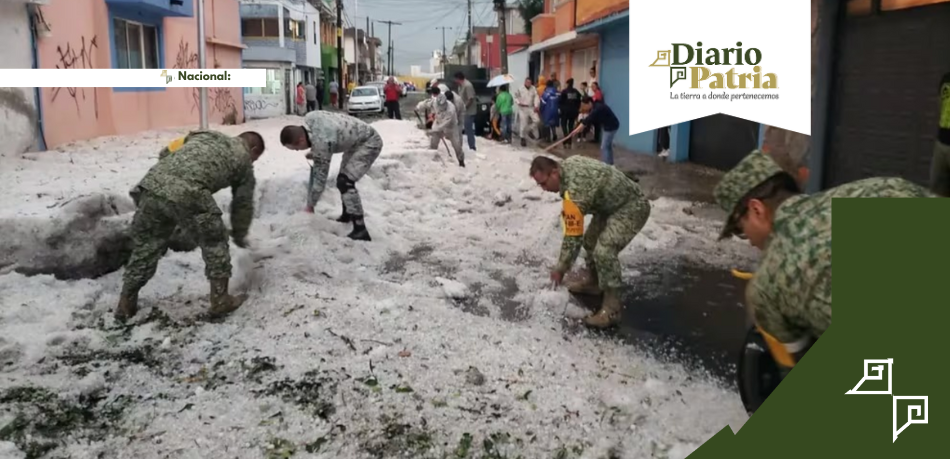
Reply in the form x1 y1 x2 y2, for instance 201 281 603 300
556 155 649 272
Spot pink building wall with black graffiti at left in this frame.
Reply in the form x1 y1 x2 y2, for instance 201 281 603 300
38 0 244 147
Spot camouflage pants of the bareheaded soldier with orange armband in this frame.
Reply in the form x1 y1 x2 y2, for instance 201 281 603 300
584 198 650 289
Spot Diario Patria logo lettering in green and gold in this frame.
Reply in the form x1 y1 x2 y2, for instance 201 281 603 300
650 41 778 100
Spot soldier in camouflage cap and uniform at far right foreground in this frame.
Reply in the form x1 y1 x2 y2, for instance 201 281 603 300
714 151 934 369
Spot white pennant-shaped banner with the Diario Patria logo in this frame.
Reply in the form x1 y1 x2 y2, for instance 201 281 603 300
629 0 811 135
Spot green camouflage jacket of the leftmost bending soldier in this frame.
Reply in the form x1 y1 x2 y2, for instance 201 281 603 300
136 127 255 239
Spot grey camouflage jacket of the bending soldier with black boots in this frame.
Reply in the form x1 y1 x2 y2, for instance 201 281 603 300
304 110 379 207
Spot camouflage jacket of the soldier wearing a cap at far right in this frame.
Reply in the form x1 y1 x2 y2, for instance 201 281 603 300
746 178 934 346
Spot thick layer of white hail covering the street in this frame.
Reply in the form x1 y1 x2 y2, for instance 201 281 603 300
0 117 760 459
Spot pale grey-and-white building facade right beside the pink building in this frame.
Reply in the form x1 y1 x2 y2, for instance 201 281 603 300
240 0 323 119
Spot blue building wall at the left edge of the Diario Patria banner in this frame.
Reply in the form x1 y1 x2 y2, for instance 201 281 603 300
597 17 656 154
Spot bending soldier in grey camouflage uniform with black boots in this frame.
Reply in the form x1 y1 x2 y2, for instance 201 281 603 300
280 111 383 241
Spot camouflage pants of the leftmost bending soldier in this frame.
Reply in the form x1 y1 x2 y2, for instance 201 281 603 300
123 191 231 292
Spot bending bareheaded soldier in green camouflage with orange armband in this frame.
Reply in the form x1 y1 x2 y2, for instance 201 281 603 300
531 156 650 328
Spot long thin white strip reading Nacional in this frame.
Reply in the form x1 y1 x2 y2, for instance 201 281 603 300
0 69 267 88
